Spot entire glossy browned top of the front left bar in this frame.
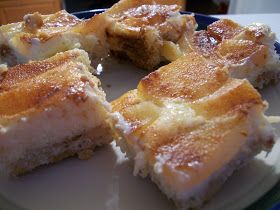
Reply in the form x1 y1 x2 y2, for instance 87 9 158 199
0 51 98 122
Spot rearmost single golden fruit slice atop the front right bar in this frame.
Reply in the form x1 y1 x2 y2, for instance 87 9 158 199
138 53 228 101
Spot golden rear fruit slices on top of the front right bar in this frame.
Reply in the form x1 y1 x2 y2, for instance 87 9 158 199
112 53 264 133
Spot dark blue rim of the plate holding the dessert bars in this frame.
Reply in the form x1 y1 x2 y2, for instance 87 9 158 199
72 9 280 210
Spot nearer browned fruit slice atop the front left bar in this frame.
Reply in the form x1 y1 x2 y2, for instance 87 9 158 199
0 64 82 117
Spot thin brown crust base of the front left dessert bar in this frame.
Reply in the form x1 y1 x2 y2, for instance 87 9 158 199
7 124 112 176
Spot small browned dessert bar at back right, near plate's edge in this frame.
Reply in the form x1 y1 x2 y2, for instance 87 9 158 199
180 19 280 88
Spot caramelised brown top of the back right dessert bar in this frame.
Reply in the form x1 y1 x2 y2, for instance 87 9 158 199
185 19 269 66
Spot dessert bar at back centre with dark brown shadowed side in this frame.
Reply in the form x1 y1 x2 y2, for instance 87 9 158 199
100 0 197 69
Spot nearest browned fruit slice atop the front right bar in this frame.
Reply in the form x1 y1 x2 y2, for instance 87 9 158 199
148 112 252 189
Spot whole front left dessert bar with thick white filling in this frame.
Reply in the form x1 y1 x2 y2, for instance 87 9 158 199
0 49 111 175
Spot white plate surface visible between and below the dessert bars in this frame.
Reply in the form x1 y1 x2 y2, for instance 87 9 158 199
0 56 280 210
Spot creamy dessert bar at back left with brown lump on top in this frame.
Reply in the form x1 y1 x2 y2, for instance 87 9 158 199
0 10 106 66
